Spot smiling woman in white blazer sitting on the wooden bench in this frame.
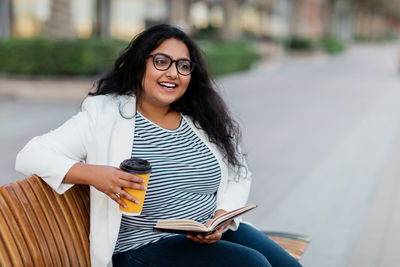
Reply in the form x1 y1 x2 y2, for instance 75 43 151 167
16 25 299 266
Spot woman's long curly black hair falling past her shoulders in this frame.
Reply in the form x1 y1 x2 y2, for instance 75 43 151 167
89 24 241 167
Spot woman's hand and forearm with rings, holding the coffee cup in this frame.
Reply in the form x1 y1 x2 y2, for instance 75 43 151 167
63 163 146 207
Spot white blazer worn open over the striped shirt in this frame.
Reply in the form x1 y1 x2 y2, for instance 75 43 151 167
15 95 251 267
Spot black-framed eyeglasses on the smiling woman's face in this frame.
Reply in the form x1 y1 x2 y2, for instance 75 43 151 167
149 53 195 76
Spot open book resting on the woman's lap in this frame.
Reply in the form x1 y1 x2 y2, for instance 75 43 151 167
153 205 257 234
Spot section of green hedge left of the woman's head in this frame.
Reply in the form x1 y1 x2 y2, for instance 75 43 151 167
0 38 126 75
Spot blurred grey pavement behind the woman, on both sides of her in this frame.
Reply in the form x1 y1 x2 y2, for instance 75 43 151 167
0 45 400 267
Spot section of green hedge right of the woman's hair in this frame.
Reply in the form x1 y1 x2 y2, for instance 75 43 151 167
200 41 261 76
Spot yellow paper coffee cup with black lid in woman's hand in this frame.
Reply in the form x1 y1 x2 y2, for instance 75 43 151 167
119 158 151 216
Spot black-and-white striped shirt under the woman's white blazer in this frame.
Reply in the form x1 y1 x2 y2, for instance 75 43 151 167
114 112 221 253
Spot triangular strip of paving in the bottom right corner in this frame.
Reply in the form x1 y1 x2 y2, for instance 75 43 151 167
349 129 400 267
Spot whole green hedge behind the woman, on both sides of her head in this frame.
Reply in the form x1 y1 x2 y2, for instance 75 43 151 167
0 38 260 76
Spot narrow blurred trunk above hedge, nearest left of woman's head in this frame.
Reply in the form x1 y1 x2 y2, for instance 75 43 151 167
93 0 111 39
